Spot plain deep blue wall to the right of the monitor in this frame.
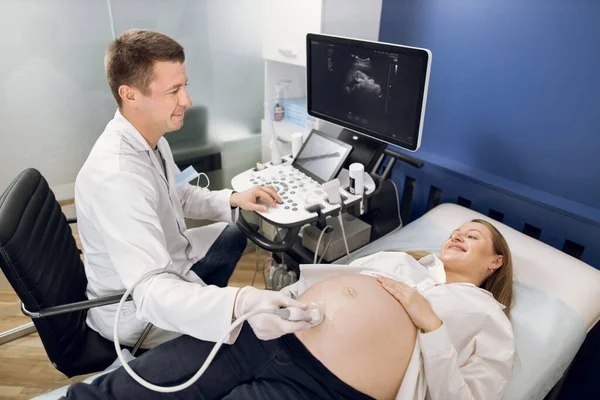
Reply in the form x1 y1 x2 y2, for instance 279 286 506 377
379 0 600 222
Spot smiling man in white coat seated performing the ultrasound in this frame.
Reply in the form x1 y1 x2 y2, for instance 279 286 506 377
75 30 310 348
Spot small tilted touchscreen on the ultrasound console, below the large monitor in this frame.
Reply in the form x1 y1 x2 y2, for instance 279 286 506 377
294 134 349 182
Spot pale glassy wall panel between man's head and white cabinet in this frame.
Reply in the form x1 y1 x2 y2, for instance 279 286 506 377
112 0 264 140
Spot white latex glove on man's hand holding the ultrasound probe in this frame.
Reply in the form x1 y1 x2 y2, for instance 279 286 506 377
234 286 311 340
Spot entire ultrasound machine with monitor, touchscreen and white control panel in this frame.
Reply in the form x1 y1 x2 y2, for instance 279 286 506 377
231 34 431 289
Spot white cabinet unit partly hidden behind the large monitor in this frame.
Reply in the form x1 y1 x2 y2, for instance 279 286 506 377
261 0 382 161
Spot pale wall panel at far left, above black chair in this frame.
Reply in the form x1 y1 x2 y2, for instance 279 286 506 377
0 0 115 196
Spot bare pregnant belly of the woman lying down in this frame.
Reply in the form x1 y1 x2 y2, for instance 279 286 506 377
296 274 417 399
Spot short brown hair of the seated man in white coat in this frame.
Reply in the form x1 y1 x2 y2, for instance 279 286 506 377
104 29 185 107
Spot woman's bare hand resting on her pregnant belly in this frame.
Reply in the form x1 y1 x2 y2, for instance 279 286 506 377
377 276 442 333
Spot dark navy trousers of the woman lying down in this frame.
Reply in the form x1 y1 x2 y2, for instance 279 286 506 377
61 323 372 400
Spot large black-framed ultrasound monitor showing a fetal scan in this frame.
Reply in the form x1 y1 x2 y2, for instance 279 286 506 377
307 34 431 151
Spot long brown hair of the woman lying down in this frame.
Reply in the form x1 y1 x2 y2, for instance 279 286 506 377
471 219 513 317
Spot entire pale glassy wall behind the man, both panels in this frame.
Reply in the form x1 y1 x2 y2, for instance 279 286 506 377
0 0 264 198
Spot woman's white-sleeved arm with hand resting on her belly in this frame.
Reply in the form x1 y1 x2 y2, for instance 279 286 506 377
378 278 514 400
